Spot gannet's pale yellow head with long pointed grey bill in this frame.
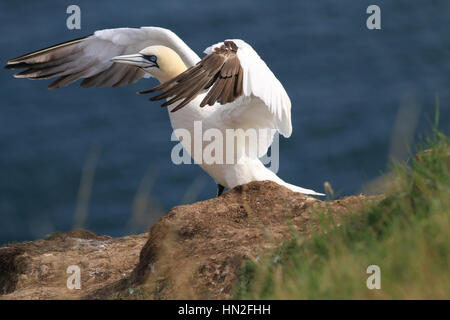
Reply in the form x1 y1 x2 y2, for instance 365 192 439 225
111 46 187 83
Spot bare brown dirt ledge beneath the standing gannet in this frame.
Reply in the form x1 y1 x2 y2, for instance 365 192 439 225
0 181 381 299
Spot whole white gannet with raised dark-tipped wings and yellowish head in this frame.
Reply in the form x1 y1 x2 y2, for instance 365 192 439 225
5 27 323 195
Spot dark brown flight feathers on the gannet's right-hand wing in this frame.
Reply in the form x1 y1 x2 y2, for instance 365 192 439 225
143 41 243 112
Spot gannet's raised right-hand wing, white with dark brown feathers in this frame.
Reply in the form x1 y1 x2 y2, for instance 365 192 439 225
141 40 292 138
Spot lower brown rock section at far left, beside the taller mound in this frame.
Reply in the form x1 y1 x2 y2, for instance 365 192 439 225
0 230 147 300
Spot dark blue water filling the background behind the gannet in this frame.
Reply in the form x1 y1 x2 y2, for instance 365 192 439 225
0 0 450 244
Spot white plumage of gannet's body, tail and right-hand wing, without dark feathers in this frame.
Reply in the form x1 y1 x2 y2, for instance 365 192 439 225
169 39 323 195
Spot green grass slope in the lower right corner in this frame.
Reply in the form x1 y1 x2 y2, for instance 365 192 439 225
234 130 450 299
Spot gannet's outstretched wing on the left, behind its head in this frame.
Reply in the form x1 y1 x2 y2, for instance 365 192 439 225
5 27 200 89
